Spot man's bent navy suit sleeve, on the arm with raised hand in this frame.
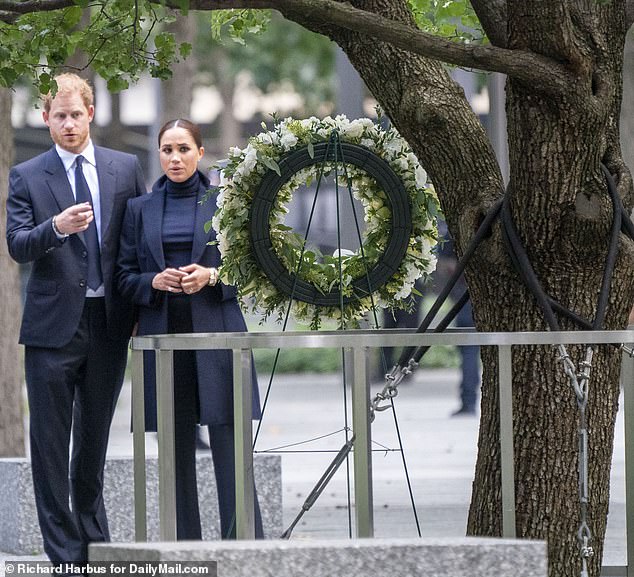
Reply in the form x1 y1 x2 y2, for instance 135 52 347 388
7 168 66 263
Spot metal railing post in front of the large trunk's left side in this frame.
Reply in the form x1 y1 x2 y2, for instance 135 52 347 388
498 345 515 539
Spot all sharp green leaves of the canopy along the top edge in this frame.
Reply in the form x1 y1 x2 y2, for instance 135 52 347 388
0 0 484 93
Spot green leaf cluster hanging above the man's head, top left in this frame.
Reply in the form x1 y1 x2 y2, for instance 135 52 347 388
0 0 191 93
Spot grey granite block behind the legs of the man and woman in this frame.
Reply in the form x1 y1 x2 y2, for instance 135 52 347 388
0 454 283 555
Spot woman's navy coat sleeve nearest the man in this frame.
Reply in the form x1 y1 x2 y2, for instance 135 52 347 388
115 199 163 308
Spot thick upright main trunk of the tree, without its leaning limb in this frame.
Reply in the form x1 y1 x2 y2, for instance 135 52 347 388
469 2 633 575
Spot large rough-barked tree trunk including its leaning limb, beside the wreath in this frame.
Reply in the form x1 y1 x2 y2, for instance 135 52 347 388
287 0 634 577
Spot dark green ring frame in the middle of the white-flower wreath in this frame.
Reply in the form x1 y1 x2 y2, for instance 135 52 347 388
249 142 412 307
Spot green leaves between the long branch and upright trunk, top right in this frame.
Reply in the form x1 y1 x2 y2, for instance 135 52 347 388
408 0 485 42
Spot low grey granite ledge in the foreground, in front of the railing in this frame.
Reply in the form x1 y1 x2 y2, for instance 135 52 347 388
89 537 548 577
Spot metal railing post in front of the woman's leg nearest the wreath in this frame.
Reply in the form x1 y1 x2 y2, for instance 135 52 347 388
233 349 255 539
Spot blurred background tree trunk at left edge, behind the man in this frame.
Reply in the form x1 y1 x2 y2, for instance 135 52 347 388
0 88 24 457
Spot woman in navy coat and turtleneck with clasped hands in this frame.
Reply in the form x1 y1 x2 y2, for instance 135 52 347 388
116 119 262 539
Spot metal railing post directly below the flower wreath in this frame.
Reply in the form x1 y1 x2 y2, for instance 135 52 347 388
352 347 374 537
